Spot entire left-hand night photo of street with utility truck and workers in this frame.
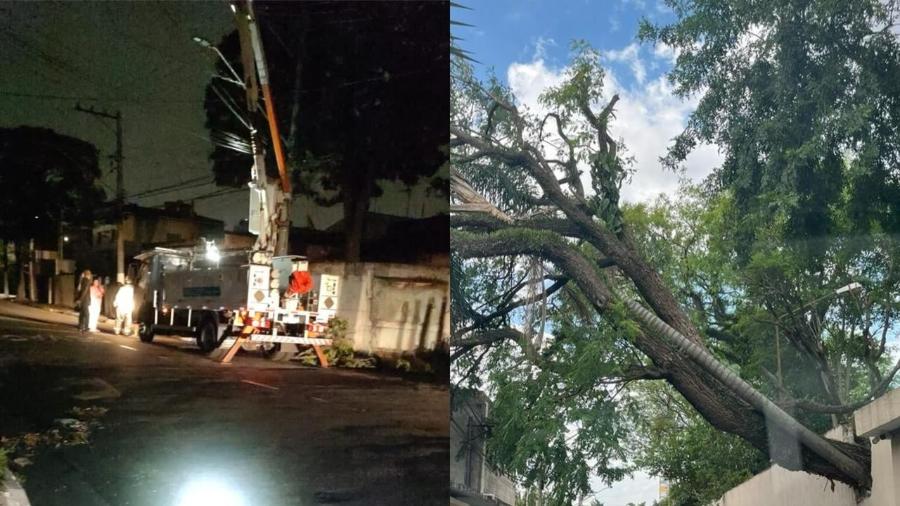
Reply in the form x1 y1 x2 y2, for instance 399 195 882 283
0 0 451 506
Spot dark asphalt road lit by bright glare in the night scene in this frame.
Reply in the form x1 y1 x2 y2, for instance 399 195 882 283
0 301 449 506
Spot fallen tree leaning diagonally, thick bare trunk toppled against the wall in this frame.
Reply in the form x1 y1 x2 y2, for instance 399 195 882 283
451 39 896 489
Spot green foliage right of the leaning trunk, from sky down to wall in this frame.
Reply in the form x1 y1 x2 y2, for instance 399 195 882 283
628 1 900 496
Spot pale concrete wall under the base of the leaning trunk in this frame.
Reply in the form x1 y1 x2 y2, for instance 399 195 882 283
715 389 900 506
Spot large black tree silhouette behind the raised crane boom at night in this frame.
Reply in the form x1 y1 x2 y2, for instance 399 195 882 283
205 2 450 261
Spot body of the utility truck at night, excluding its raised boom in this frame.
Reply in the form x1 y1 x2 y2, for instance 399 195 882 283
135 243 340 356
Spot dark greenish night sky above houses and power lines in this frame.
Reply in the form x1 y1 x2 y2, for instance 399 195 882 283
0 1 447 227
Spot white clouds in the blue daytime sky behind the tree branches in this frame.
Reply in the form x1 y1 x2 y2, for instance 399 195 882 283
507 44 722 202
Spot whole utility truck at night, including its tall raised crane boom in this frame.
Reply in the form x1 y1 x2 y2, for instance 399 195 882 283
136 0 340 366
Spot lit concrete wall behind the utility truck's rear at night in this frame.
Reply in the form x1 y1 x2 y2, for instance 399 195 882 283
310 262 450 353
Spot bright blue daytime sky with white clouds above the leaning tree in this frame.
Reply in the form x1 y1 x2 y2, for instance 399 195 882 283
451 0 721 206
